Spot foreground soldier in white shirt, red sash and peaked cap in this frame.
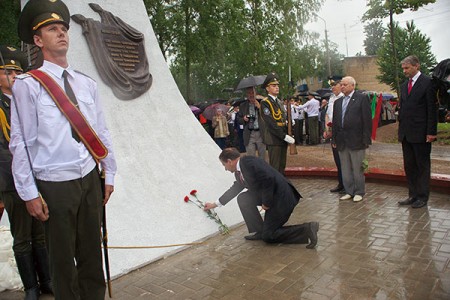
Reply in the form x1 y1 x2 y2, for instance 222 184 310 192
9 0 116 300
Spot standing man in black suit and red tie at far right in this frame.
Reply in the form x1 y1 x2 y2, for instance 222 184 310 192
398 55 437 208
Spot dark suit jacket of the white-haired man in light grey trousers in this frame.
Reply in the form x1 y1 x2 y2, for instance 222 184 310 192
332 91 372 151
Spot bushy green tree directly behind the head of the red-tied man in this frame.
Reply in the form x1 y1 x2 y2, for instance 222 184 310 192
377 22 436 95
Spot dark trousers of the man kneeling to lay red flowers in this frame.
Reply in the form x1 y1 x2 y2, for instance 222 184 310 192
237 191 310 244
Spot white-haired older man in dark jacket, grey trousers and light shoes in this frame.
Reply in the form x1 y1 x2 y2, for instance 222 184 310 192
332 76 372 202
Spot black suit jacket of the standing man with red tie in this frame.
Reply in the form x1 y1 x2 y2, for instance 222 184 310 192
398 74 437 143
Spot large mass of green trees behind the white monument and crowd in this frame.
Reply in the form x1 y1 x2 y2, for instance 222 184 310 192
145 0 326 102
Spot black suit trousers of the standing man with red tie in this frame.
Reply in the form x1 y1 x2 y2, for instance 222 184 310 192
402 138 431 202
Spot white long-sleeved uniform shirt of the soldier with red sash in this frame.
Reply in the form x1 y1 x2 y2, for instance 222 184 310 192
9 61 117 201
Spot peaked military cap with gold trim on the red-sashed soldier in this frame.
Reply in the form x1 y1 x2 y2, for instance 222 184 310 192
18 0 70 44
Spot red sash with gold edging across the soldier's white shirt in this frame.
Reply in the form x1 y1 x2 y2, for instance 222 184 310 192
27 70 108 161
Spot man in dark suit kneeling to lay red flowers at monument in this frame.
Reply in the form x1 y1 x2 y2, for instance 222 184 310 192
205 148 319 249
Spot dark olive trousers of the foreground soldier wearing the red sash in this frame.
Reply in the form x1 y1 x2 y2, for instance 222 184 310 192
37 168 106 300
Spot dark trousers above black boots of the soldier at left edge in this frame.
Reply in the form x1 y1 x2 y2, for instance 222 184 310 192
0 191 45 256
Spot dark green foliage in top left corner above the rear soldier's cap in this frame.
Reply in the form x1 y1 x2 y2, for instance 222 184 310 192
0 0 20 48
